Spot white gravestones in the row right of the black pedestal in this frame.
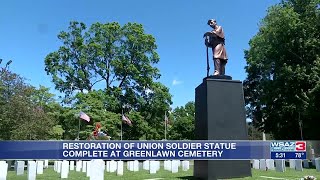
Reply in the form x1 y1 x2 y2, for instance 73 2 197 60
252 158 320 172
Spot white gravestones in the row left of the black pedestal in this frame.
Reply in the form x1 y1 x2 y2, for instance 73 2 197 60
0 160 190 180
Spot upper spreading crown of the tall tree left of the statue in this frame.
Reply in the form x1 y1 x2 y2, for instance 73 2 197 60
45 22 160 100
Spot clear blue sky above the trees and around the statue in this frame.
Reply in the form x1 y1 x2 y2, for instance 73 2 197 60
0 0 279 107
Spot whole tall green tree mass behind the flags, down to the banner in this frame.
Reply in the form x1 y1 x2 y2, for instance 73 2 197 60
45 22 172 139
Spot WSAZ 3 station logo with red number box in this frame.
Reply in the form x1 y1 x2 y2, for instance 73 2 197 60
270 141 307 152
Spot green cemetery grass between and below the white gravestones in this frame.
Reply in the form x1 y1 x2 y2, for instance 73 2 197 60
7 166 320 180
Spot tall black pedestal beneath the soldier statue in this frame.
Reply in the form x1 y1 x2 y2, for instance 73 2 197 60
194 76 251 179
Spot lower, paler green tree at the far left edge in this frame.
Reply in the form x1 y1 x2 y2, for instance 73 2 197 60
0 65 55 140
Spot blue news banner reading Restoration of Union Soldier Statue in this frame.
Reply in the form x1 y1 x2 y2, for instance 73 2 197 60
0 140 307 160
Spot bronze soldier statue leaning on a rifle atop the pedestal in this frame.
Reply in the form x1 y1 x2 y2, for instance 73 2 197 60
203 19 228 76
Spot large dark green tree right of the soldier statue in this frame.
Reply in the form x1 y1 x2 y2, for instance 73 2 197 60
244 0 320 139
